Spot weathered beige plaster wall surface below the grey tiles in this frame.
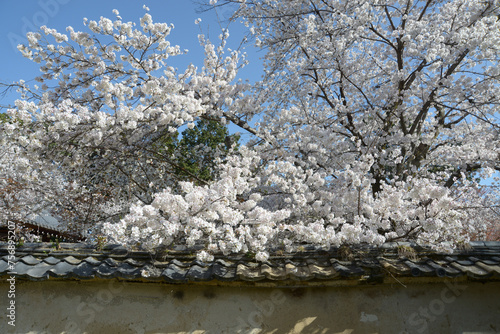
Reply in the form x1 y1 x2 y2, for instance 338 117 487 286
0 281 500 334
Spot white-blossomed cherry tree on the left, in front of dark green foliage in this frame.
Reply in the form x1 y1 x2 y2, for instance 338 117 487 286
2 6 245 239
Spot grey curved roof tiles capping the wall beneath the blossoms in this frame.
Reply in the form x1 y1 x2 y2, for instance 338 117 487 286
0 242 500 283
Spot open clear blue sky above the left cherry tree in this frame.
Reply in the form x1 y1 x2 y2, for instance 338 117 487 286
0 0 262 109
